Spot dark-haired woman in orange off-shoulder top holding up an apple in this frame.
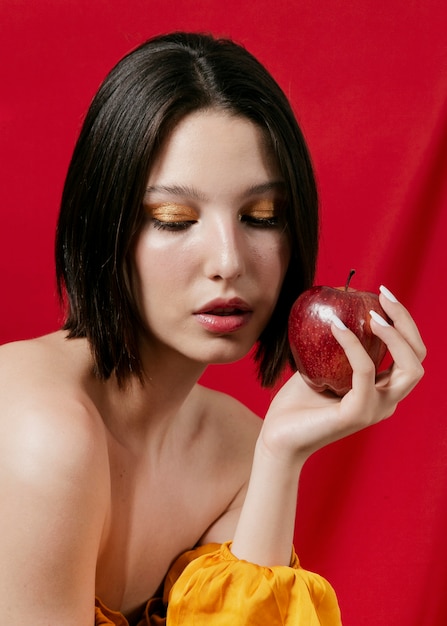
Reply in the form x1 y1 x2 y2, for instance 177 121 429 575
0 33 425 626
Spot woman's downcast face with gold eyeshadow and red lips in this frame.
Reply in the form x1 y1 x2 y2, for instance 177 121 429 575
134 110 290 364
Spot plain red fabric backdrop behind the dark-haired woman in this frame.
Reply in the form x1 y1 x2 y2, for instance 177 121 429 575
0 0 447 626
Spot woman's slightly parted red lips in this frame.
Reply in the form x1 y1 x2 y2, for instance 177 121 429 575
194 298 253 334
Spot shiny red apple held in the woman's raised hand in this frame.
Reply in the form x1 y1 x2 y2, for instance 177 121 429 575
289 270 391 396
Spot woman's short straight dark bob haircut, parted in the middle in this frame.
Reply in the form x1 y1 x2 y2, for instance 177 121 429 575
56 32 318 386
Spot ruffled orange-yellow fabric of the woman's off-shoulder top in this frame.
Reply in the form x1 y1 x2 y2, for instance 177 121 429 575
95 542 341 626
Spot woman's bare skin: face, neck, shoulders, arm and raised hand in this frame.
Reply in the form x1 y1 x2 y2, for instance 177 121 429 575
0 110 425 626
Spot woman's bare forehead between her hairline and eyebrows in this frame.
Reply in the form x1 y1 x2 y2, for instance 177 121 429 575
148 109 281 193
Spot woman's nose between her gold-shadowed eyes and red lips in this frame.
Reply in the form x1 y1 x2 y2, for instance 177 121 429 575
206 220 246 281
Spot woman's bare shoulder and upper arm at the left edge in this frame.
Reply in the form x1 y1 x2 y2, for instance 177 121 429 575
0 337 107 624
